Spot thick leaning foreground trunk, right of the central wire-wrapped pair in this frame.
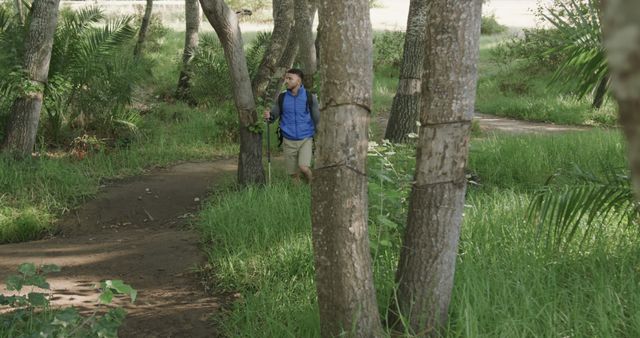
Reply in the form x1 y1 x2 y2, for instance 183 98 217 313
390 0 482 336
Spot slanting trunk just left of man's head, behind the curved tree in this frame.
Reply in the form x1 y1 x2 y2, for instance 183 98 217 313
252 0 294 100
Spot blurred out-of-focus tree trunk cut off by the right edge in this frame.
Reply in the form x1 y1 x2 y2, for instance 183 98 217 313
601 0 640 200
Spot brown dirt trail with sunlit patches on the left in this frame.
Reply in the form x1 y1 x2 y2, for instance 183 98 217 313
0 160 236 337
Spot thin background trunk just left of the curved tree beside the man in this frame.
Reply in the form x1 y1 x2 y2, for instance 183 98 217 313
176 0 200 105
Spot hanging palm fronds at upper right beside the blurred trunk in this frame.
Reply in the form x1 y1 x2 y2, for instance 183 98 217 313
540 0 609 108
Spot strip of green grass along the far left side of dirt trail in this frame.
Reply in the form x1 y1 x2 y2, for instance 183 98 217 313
0 105 237 243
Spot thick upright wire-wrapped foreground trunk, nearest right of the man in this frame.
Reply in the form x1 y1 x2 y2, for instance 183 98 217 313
311 0 382 337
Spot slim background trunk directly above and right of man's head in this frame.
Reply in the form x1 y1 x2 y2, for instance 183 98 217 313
294 0 318 90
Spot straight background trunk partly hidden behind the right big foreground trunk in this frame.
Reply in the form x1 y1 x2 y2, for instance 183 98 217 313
384 0 428 142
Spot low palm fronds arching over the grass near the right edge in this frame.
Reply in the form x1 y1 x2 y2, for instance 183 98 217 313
528 168 640 249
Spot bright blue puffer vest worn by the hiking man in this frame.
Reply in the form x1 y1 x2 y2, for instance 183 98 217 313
271 86 319 141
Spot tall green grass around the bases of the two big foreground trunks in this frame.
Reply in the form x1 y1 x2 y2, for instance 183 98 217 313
200 131 640 337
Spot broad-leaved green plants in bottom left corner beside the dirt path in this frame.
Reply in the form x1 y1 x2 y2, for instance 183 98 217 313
0 263 137 338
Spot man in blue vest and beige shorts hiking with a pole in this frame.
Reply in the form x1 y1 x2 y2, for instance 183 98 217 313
264 68 320 182
